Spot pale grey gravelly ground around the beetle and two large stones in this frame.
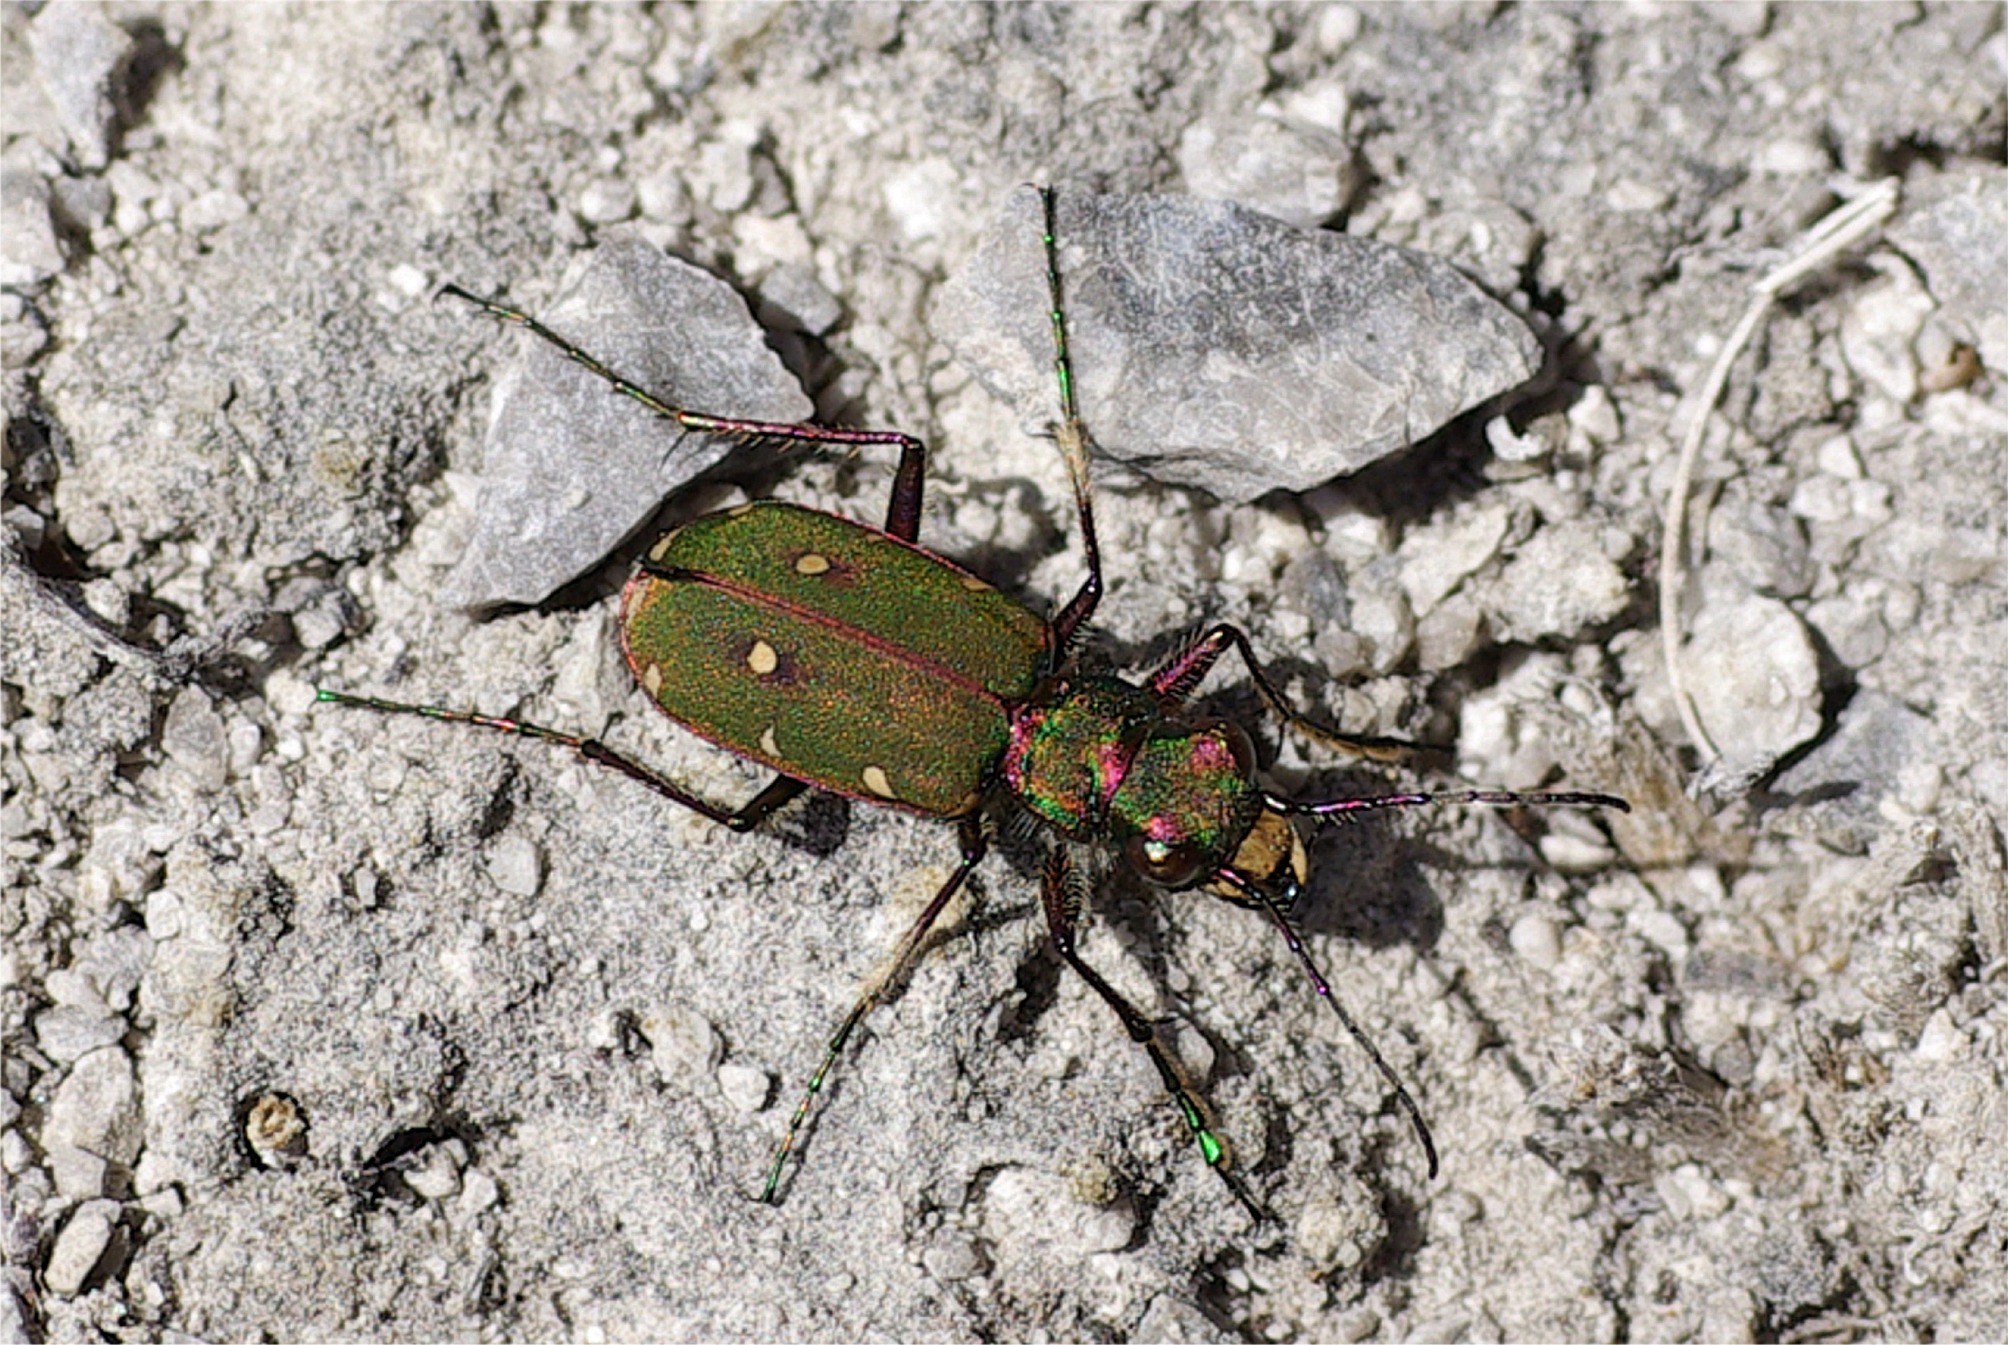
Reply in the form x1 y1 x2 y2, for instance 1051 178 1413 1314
0 4 2008 1341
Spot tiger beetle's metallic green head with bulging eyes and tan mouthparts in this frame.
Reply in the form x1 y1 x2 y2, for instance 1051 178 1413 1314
1108 719 1303 901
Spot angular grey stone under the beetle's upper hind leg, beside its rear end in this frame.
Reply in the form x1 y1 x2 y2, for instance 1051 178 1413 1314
444 237 813 608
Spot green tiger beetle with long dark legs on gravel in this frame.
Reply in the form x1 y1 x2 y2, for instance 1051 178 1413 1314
317 189 1628 1221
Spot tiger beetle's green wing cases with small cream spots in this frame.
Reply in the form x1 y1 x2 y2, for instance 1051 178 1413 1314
620 500 1046 817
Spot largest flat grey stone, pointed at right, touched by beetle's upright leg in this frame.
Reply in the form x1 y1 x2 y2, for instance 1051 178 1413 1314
932 189 1540 502
